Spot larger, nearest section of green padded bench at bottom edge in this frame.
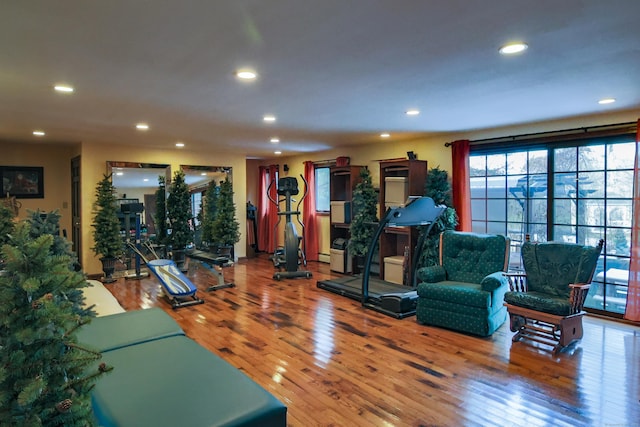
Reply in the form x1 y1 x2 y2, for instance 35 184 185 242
92 335 287 427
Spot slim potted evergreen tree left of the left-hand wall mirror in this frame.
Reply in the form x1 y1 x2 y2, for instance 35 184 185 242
91 174 123 283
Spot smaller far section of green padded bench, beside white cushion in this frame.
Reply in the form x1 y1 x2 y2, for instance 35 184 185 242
78 307 184 353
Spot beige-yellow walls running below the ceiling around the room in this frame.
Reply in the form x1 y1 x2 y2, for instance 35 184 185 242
0 108 640 274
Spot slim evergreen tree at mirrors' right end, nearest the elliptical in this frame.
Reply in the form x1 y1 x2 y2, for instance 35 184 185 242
211 176 240 256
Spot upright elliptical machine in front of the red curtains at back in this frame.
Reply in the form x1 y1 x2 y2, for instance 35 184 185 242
267 175 311 280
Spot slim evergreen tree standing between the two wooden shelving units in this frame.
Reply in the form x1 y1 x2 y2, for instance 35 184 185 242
347 167 378 267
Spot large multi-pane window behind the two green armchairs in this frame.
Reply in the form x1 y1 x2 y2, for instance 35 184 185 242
469 136 635 314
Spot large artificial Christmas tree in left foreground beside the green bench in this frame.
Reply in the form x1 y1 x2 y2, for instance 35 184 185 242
0 221 110 426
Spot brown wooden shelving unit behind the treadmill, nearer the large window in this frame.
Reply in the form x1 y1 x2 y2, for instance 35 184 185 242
380 159 427 284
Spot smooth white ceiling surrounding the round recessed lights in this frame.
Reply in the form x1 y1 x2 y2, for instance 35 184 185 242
0 0 640 157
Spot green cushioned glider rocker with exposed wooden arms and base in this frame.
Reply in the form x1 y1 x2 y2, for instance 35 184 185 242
504 236 604 353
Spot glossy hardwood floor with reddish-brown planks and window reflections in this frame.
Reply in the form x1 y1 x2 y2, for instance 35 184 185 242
107 256 640 426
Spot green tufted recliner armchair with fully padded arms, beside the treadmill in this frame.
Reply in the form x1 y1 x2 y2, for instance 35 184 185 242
416 230 509 336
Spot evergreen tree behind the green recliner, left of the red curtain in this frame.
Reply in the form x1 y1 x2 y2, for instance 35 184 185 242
419 166 458 267
